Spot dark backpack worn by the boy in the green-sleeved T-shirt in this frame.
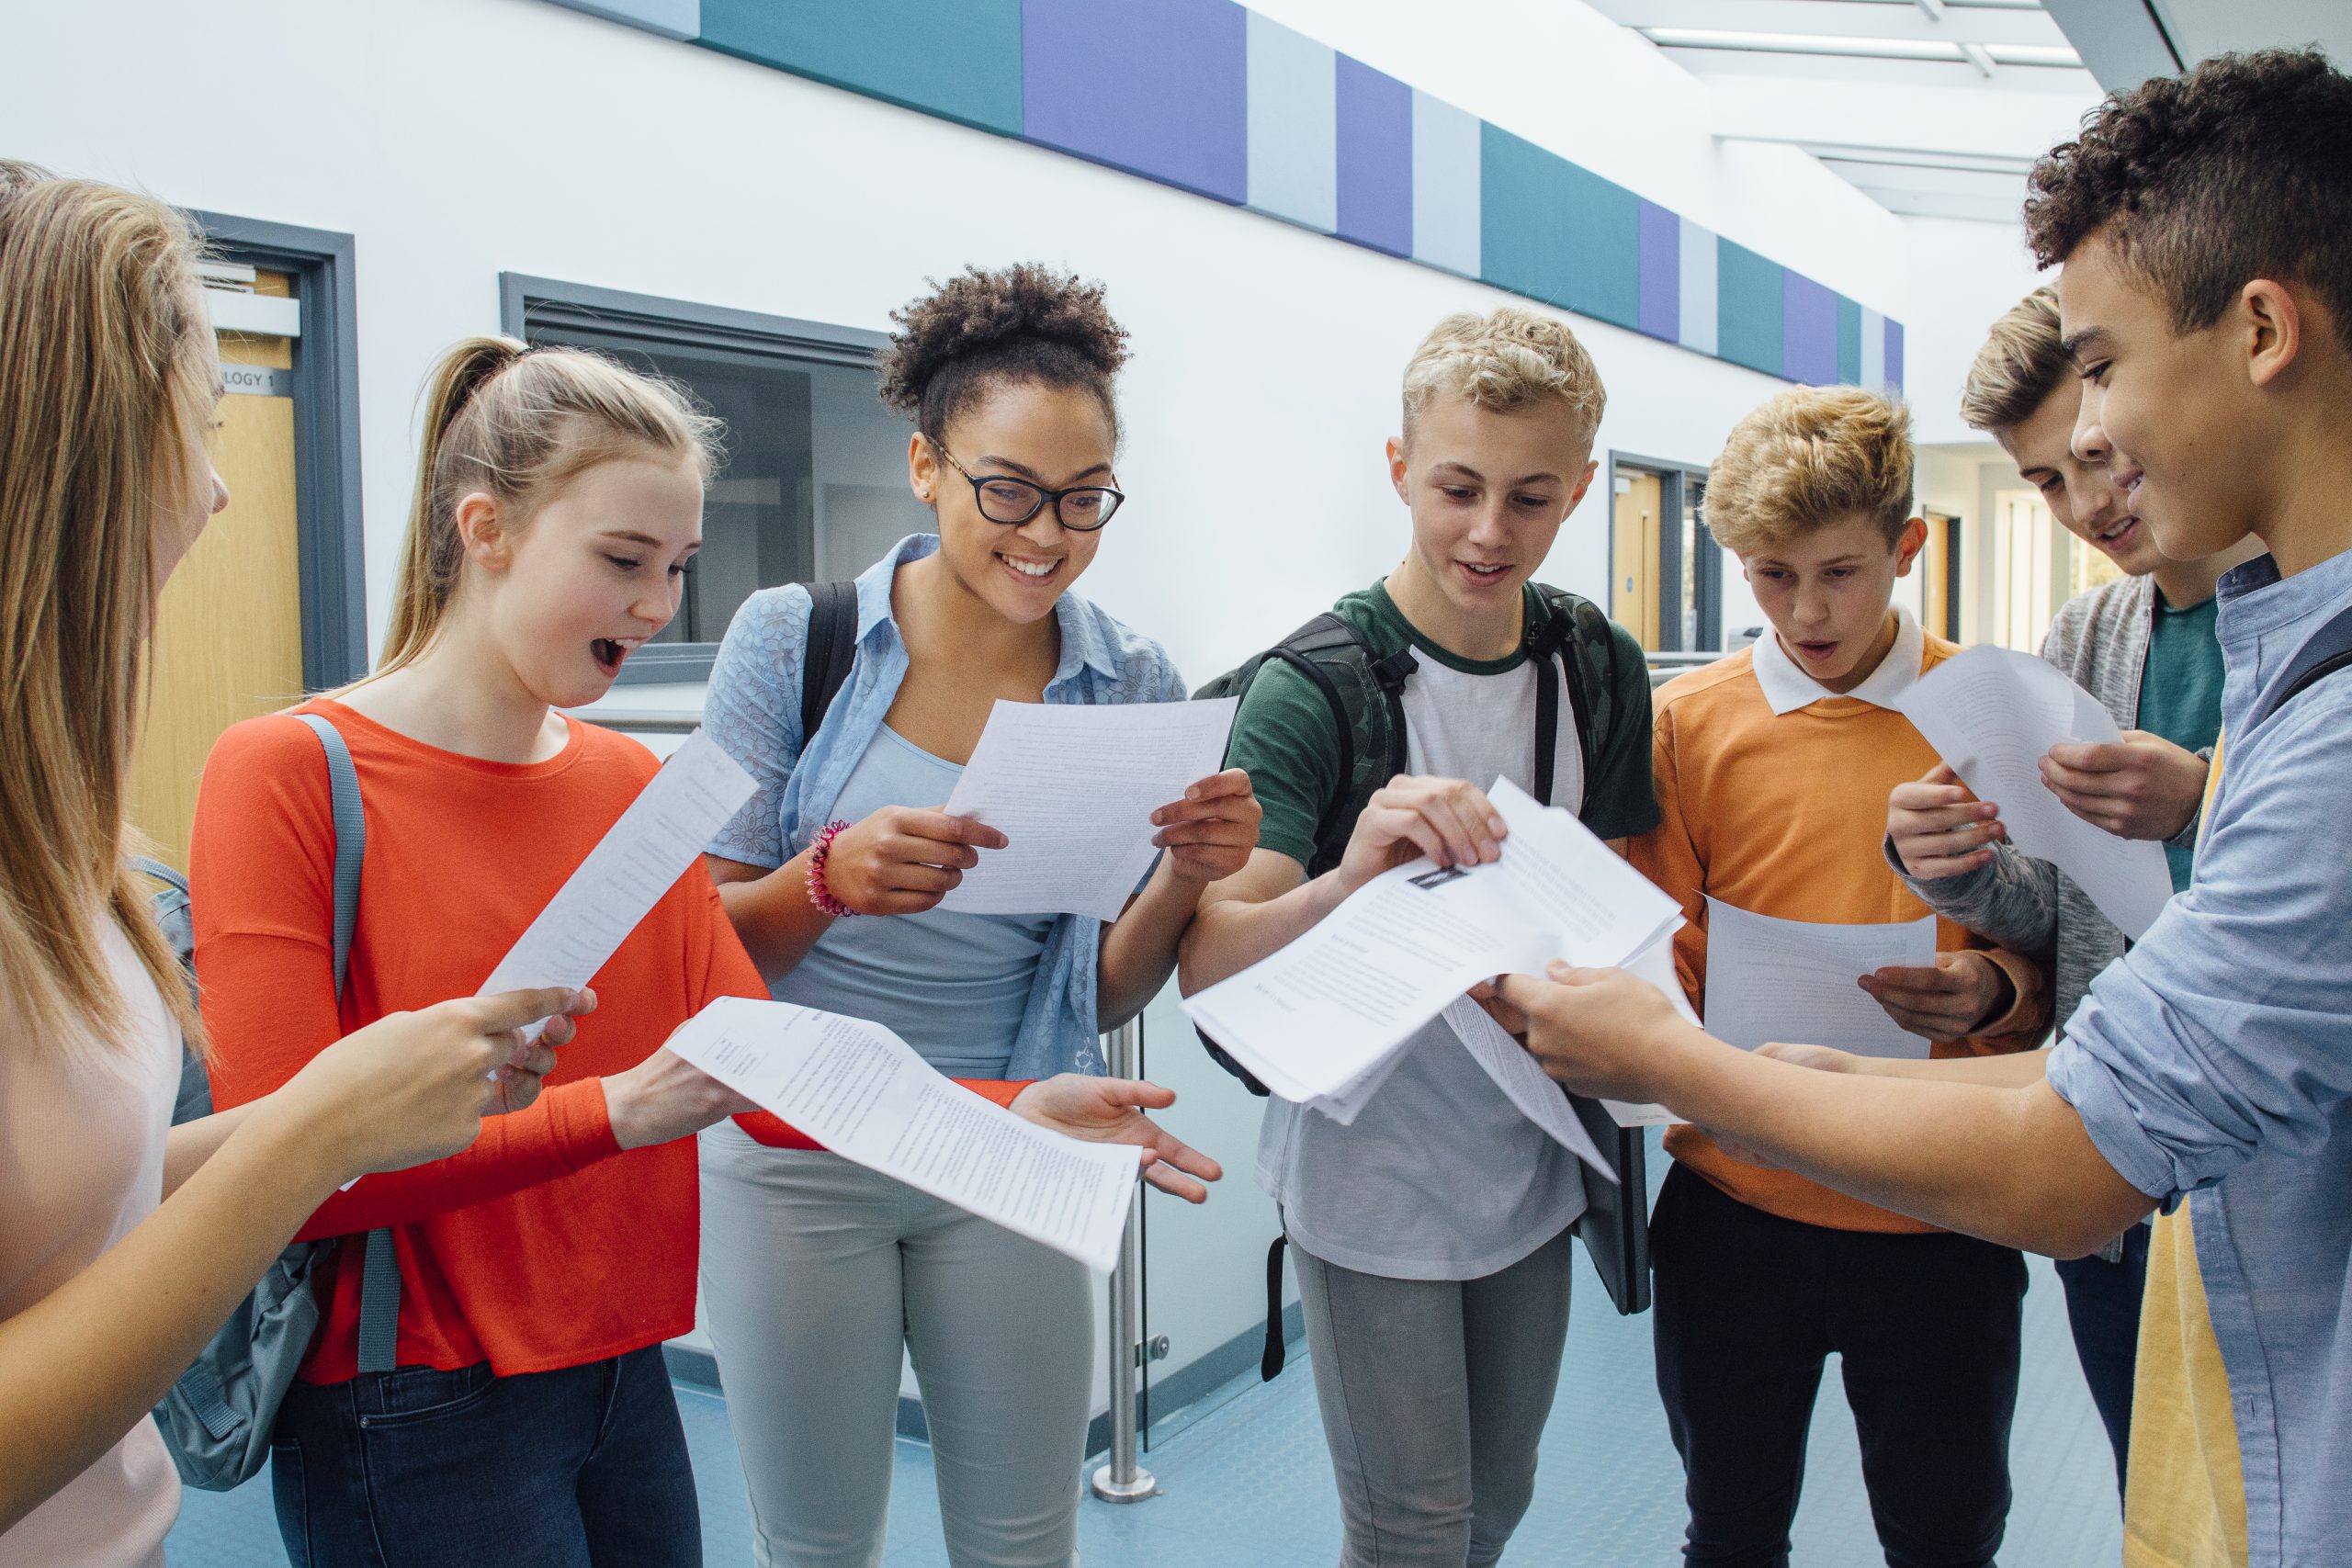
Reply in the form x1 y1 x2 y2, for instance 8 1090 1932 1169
1193 583 1649 1354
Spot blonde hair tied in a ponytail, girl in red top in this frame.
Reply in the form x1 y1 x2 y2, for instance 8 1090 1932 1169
377 336 719 674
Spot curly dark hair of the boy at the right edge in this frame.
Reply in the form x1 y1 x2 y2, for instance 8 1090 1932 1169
2025 50 2352 341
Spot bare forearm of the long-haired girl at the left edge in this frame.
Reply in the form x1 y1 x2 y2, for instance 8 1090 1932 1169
0 1107 348 1533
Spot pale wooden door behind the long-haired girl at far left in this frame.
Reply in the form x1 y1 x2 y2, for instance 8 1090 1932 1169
130 273 303 870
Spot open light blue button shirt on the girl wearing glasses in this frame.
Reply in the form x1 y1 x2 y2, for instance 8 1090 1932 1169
703 534 1185 1079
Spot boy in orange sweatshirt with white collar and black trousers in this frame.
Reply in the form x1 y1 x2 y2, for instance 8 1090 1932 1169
1630 388 2049 1568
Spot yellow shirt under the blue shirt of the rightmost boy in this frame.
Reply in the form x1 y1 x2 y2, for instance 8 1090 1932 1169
2124 740 2246 1568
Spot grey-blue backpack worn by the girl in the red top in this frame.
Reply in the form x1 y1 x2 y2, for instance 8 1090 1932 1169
141 712 400 1493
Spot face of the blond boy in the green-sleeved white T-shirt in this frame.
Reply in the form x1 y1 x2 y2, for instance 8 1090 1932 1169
1387 398 1595 635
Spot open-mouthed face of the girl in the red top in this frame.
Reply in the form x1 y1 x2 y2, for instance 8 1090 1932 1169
457 458 703 707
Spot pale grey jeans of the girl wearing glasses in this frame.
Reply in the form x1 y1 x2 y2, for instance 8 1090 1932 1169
701 1122 1093 1568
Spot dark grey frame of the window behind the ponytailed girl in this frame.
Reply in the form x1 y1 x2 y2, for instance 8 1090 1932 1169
499 273 889 686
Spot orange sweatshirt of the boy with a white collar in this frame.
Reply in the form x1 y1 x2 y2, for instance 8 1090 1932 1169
1630 637 2051 1232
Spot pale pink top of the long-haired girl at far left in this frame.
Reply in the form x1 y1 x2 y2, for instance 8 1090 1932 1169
0 919 181 1568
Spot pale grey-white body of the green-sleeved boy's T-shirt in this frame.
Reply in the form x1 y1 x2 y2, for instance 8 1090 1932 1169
1259 647 1585 1279
